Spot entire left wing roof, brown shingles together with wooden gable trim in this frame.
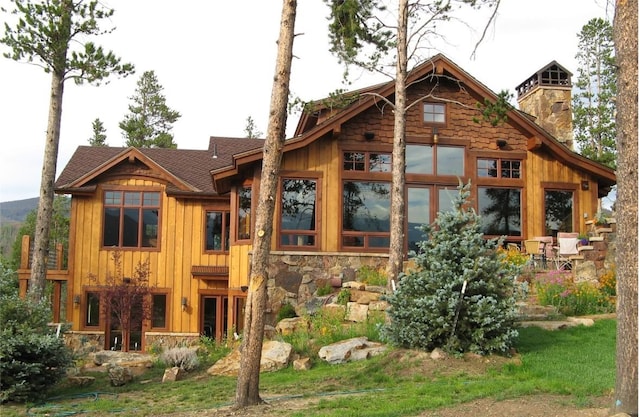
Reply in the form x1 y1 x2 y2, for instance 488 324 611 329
55 137 264 195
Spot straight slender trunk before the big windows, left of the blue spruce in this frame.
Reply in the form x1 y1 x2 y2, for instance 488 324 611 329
387 0 408 285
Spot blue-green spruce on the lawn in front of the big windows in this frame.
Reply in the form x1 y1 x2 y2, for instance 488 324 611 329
385 183 519 354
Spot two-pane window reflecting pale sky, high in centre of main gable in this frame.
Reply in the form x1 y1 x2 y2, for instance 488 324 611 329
406 144 464 176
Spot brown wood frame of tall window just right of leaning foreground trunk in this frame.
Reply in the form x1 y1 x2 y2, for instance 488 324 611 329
276 171 322 251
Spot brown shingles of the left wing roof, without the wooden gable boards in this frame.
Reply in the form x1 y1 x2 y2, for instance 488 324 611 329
55 137 264 194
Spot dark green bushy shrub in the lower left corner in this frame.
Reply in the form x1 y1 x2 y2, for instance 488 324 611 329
0 284 73 402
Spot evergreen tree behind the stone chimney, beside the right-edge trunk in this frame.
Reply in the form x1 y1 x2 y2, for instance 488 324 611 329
573 18 617 169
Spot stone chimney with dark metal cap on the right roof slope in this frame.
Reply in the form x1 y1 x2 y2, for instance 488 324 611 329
516 61 573 149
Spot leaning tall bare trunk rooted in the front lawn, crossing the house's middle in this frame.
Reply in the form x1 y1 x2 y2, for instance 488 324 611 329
236 0 297 407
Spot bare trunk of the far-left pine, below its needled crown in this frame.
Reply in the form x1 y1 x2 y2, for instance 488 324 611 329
28 72 64 301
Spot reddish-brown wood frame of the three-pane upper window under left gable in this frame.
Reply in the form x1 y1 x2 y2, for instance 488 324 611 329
100 186 164 252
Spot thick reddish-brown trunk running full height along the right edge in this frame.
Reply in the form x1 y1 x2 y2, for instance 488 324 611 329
613 0 638 416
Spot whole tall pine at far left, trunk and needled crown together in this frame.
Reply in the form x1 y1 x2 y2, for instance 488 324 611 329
0 0 133 301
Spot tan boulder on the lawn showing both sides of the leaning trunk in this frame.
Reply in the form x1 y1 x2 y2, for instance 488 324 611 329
207 340 293 376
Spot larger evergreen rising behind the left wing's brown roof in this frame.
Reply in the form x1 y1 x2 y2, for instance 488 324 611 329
119 71 181 149
